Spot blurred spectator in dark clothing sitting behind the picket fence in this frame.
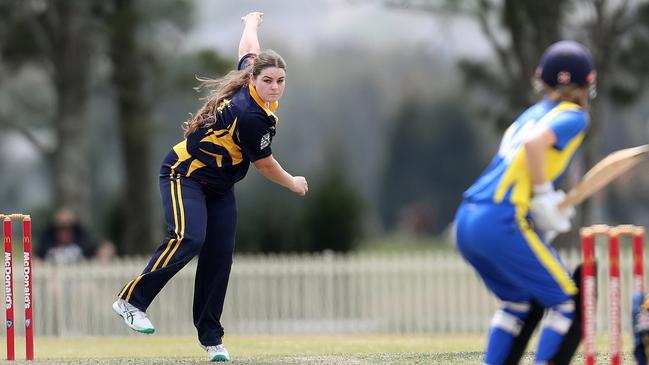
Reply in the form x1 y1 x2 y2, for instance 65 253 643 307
36 208 115 264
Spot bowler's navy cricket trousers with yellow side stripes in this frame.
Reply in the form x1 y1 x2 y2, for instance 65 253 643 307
119 175 237 346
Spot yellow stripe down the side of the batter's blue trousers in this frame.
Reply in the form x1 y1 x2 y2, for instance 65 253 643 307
516 207 577 295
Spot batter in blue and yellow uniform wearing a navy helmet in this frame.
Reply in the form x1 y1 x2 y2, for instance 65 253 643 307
456 41 595 365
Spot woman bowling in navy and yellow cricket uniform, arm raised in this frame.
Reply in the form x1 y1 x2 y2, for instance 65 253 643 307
113 12 308 361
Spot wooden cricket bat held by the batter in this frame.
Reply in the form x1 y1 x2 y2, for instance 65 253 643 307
559 144 649 209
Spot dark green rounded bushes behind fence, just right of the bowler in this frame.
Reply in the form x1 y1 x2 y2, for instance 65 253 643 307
236 166 364 252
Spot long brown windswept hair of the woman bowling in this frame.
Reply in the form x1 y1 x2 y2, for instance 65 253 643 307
182 49 286 138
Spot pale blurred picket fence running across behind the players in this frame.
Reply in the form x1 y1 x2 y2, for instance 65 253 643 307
3 247 644 336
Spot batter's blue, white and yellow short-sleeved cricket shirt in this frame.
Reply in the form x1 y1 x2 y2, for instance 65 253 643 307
464 100 588 207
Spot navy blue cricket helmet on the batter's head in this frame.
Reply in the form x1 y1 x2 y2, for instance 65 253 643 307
536 41 595 88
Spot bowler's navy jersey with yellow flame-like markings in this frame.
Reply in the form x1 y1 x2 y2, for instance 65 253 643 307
161 63 279 191
